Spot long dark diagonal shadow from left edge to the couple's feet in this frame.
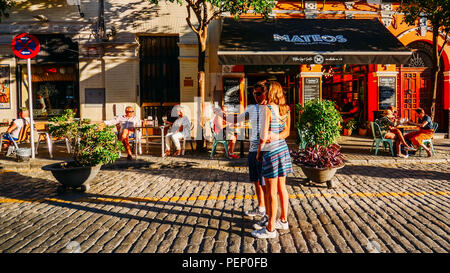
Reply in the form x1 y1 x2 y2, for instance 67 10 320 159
0 168 253 239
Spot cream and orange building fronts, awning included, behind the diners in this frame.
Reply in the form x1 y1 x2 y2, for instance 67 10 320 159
0 0 450 136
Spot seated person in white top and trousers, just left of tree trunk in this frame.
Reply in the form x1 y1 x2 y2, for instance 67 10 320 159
164 106 191 156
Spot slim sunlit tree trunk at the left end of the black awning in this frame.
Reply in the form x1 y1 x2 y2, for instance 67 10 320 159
197 29 208 151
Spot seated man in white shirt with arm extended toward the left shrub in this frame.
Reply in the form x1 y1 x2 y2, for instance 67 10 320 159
103 106 140 160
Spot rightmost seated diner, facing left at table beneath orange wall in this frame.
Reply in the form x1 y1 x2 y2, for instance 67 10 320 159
405 108 434 157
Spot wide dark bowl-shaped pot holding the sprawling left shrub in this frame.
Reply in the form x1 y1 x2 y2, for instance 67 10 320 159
42 162 102 193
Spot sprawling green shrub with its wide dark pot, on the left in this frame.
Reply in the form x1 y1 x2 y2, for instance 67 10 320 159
42 109 123 193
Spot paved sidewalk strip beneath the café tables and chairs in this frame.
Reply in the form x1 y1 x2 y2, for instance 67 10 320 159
0 136 450 170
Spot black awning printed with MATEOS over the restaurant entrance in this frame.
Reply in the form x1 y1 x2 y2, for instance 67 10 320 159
218 18 412 65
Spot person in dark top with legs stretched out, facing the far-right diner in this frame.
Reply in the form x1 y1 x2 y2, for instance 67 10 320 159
376 107 415 158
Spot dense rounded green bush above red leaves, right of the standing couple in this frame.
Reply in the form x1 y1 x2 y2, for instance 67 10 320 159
295 99 342 147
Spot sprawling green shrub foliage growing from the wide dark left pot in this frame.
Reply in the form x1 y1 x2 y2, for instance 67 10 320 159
49 109 124 166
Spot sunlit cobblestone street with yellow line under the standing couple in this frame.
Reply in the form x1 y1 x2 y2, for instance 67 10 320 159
0 157 450 253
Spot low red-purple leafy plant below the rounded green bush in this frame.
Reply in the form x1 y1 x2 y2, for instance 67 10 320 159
291 144 344 169
